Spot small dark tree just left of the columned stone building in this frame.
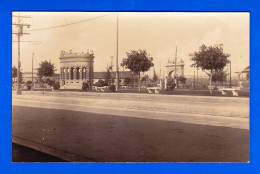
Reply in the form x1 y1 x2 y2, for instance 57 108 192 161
37 60 56 86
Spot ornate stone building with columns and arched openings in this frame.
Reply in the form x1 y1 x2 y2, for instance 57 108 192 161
60 50 94 89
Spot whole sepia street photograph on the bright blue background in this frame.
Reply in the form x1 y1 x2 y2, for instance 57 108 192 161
10 11 250 163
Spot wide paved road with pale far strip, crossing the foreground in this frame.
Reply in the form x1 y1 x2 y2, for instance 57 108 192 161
13 95 249 162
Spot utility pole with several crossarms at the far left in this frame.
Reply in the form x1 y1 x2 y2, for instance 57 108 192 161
12 13 30 95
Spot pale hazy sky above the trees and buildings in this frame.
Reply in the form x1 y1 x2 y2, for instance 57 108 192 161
12 12 250 76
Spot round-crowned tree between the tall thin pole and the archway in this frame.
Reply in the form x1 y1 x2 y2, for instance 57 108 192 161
121 49 154 92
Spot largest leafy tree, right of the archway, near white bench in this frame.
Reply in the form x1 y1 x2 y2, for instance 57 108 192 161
190 44 230 94
